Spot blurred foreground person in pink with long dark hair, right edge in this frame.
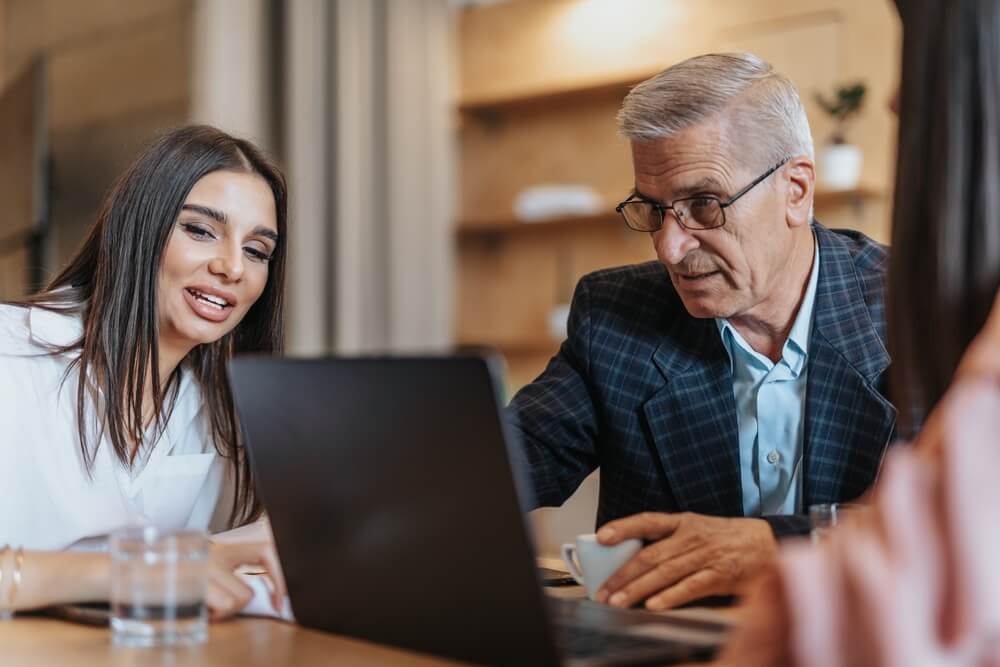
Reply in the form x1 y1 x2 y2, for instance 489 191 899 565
722 0 1000 667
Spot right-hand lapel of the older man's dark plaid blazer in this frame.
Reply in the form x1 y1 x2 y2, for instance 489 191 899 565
803 225 896 507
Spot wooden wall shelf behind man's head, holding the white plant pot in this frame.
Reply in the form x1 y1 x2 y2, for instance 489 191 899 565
456 187 883 239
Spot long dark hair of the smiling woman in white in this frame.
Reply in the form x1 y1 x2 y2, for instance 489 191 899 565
19 125 287 525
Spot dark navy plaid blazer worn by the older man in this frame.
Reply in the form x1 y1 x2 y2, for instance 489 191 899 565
507 223 896 535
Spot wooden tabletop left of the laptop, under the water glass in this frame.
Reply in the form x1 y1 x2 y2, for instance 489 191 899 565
0 617 458 667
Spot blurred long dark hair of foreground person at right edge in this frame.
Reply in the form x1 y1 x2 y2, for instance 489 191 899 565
888 0 1000 434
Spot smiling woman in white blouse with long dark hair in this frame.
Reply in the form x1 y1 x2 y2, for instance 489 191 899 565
0 126 287 618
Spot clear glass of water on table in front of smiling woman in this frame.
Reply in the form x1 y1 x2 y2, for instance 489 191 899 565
111 527 209 647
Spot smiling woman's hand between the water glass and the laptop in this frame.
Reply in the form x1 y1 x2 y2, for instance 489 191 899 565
205 541 285 621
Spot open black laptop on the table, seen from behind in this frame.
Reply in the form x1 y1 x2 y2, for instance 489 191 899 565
230 356 725 666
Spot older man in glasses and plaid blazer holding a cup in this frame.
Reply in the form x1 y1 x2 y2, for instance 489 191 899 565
508 54 895 609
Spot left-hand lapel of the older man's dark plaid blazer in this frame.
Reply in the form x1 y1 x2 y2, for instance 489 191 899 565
643 313 743 516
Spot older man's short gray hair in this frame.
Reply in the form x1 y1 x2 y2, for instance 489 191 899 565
618 53 813 164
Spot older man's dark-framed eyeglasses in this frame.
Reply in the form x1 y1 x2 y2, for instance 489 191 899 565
615 157 791 232
